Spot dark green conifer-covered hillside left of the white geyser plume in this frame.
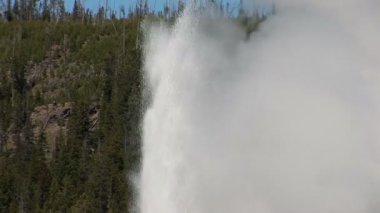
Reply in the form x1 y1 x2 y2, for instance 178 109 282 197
0 0 262 212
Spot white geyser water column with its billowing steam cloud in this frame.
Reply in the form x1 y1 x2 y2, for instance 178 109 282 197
138 0 380 213
